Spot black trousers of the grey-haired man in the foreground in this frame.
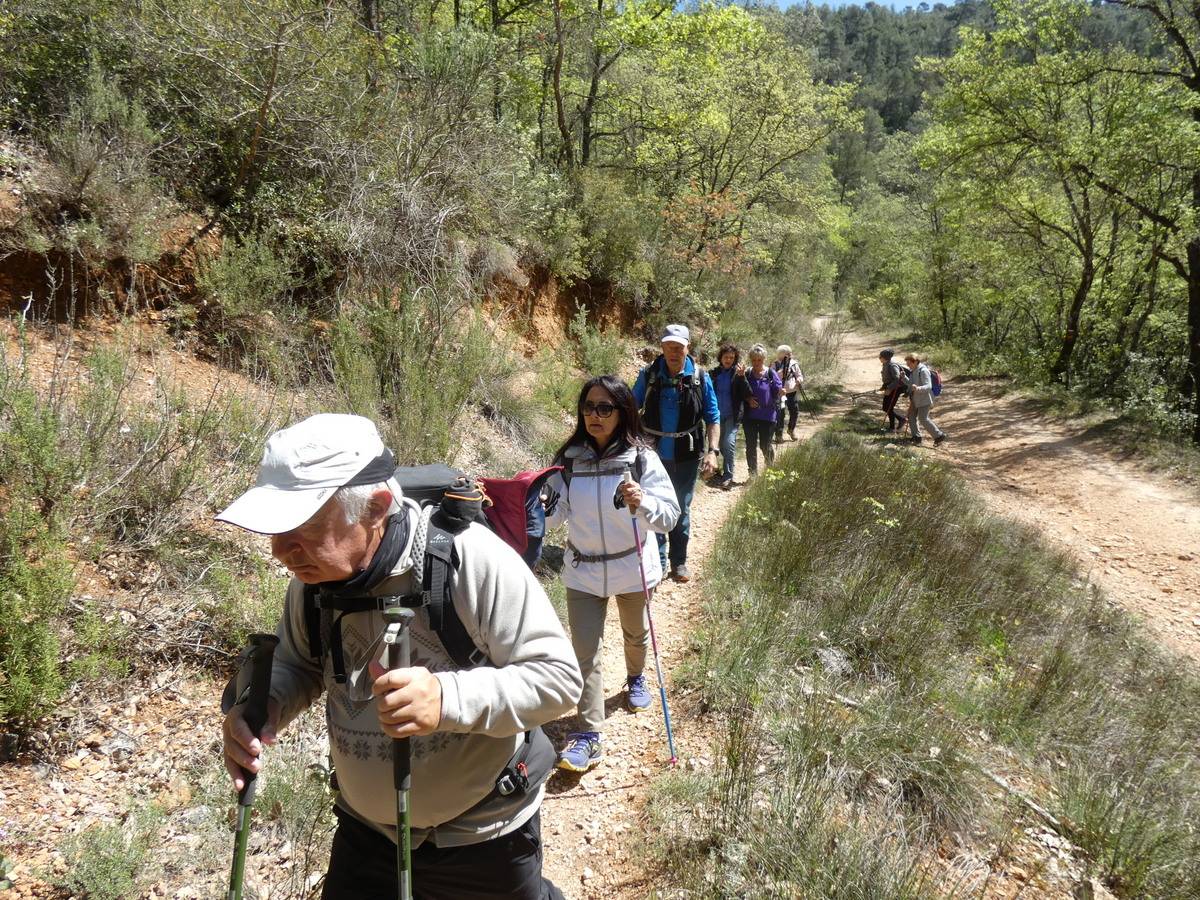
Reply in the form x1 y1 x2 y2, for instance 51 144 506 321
320 810 563 900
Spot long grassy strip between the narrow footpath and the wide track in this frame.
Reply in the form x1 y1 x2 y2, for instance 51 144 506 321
659 418 1200 898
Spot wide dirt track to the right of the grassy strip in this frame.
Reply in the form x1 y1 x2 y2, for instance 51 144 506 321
841 332 1200 659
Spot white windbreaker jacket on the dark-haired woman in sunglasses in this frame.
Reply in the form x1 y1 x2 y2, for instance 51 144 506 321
546 444 679 596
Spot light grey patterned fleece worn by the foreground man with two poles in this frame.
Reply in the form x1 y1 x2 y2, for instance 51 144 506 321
265 506 583 847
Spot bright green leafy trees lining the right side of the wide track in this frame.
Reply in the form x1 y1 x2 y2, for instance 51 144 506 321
835 0 1200 440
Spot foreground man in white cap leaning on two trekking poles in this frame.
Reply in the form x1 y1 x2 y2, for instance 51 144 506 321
217 415 582 900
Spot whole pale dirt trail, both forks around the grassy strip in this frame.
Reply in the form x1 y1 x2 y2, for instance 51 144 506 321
542 323 1200 900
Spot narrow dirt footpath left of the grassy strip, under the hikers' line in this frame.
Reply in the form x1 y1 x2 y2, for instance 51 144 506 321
542 319 859 900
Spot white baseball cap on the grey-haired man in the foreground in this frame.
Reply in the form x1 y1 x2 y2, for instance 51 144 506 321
216 413 400 534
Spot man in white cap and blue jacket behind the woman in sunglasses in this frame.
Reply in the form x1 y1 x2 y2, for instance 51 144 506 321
634 325 721 582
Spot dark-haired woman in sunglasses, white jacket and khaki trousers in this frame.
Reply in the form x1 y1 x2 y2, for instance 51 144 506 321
546 376 679 772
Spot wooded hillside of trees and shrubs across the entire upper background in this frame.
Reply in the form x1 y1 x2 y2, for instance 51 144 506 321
0 0 1200 437
